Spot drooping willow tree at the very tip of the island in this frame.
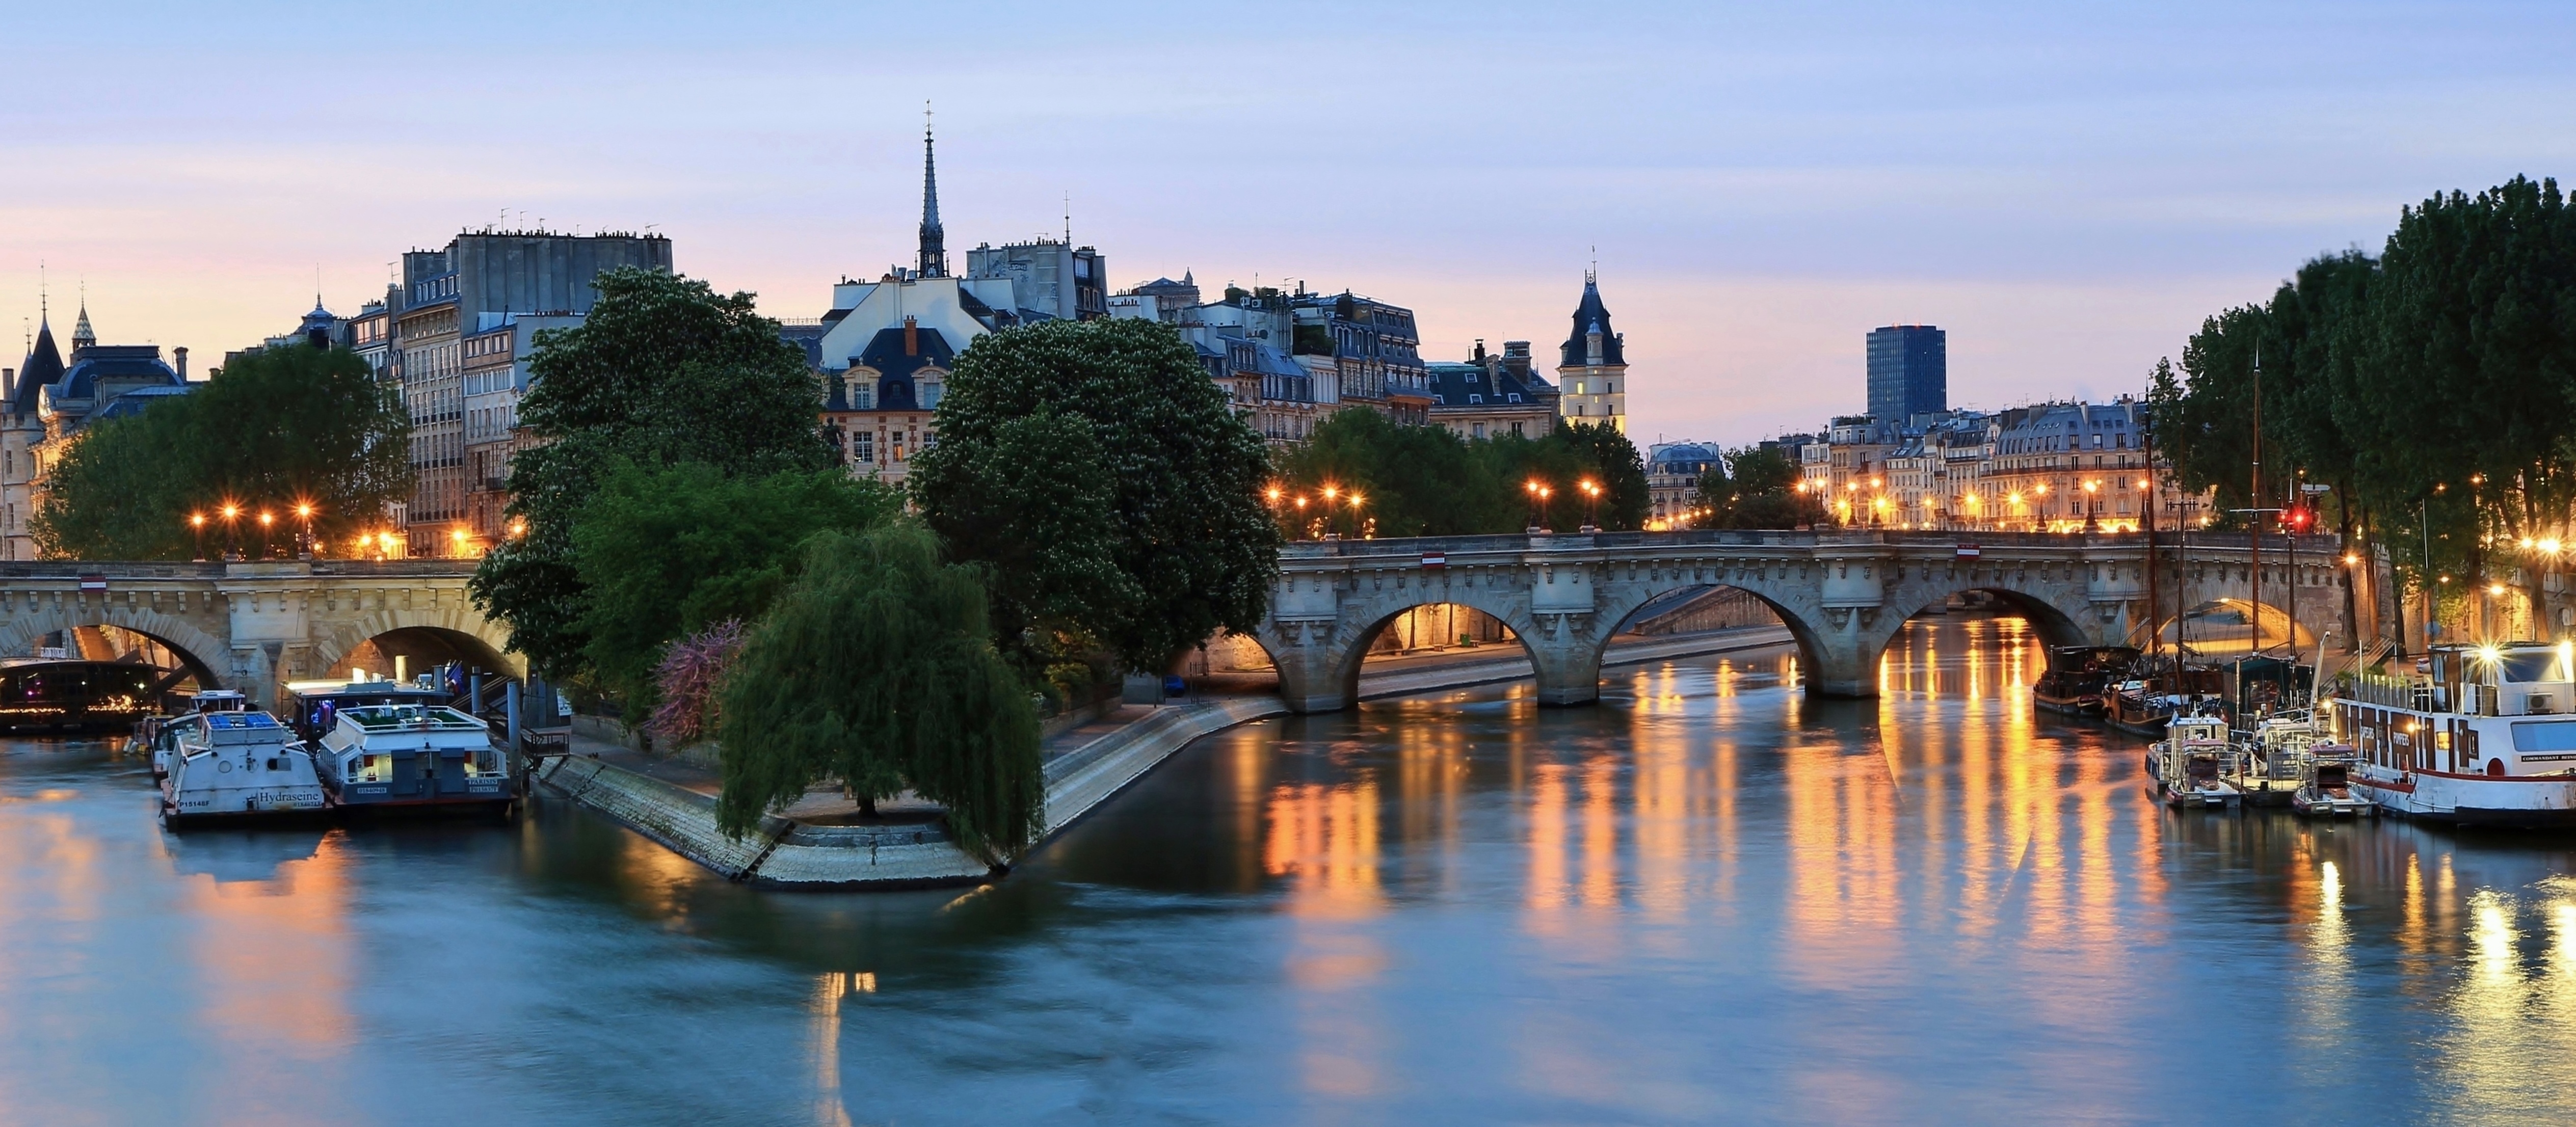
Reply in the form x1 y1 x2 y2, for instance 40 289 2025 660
716 525 1046 865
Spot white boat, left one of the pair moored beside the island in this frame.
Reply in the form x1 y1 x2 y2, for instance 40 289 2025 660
152 710 327 826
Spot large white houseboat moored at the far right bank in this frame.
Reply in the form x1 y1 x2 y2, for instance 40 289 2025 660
2329 643 2576 828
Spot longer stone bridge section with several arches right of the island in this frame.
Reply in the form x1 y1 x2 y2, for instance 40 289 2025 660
1257 530 2352 713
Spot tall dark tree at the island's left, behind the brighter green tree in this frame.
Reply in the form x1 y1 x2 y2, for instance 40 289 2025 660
471 267 837 679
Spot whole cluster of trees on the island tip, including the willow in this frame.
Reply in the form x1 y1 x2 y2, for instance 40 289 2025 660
458 270 1278 862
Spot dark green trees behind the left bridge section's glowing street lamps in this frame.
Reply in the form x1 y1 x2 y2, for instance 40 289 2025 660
31 345 412 558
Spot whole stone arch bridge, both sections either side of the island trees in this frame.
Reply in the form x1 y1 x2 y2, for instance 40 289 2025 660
0 530 2352 713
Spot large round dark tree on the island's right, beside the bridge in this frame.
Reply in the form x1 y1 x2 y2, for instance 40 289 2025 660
912 319 1278 669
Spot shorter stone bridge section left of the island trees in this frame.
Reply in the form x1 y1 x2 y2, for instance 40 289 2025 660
0 561 525 703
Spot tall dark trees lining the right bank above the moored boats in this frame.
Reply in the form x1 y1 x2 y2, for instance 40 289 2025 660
2151 177 2576 625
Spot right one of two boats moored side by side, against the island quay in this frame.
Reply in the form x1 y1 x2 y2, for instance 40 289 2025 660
314 705 518 811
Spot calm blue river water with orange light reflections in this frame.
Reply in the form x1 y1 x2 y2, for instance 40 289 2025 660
0 618 2576 1127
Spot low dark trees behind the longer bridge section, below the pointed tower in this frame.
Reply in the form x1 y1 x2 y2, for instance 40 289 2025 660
1278 412 1651 535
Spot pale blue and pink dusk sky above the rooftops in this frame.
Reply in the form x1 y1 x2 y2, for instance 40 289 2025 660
0 3 2576 443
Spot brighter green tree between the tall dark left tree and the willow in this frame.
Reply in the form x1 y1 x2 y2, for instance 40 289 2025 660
572 461 901 715
